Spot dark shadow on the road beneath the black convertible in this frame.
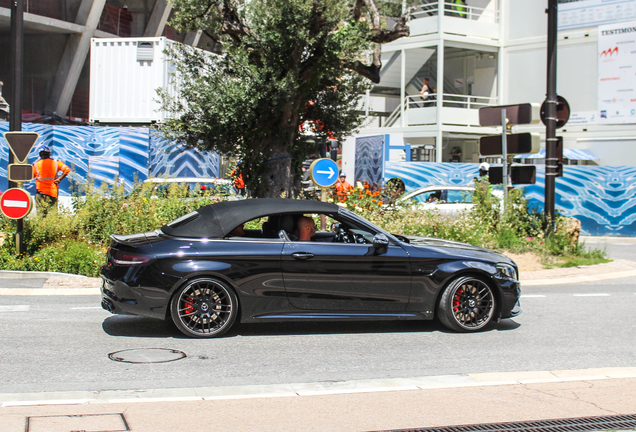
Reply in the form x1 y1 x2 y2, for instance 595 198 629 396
102 315 520 339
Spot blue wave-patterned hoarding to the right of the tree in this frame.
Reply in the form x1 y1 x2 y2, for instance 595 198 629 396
385 162 636 236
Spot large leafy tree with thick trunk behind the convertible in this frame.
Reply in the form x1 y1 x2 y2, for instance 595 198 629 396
161 0 409 197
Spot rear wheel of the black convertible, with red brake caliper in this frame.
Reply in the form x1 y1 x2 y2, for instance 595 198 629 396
170 278 238 338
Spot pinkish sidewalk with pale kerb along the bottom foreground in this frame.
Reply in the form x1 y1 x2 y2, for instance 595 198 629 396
0 368 636 432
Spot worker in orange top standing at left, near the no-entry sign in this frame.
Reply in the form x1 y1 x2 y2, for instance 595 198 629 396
33 145 71 214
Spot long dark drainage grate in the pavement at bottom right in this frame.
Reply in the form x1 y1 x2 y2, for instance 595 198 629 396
384 415 636 432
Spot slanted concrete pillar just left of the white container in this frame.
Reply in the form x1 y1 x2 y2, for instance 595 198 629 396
45 0 106 117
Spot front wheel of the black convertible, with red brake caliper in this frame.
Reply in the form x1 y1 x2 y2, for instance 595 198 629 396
439 277 495 332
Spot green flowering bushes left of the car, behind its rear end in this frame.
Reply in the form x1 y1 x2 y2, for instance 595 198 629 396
0 182 226 276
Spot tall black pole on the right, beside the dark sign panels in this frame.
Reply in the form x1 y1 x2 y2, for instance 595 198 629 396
545 0 558 237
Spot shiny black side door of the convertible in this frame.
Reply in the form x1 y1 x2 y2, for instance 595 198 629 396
282 241 411 312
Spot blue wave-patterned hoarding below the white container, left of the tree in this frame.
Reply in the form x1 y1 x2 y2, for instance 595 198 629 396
0 122 219 197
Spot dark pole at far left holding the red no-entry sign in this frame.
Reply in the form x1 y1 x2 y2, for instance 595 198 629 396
9 0 24 255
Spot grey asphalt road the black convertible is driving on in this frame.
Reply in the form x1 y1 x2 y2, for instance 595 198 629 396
0 278 636 393
